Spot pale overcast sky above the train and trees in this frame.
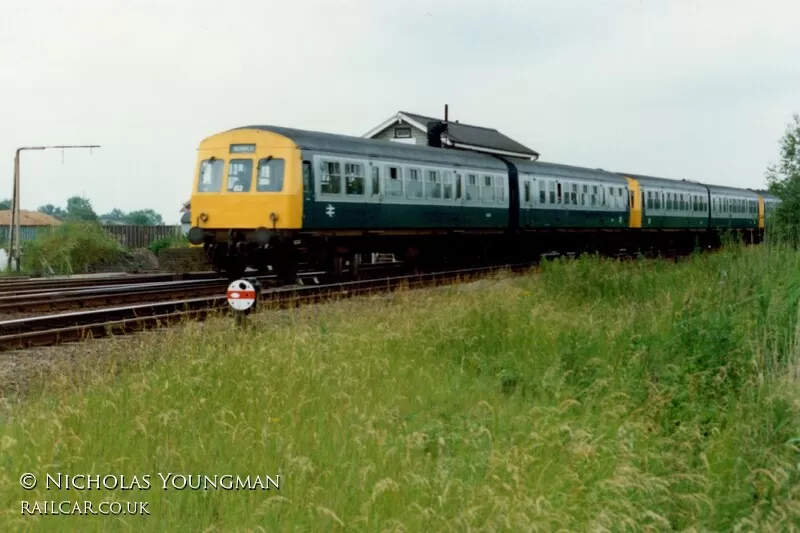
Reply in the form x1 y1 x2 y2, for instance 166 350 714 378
0 0 800 223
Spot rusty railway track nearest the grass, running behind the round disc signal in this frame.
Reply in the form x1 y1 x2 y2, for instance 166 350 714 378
0 263 534 351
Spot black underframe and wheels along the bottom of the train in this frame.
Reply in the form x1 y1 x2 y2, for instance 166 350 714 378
204 225 763 283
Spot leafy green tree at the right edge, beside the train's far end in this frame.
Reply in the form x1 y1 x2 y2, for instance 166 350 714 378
767 113 800 228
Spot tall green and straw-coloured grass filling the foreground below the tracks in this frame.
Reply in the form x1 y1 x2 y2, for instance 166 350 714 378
0 244 800 532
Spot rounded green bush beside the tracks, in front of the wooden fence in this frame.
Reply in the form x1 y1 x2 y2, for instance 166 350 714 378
21 222 125 274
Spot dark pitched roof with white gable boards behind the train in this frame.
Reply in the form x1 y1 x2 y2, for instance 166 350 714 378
364 111 539 159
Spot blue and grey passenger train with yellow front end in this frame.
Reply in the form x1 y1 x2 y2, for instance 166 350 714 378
187 126 779 282
